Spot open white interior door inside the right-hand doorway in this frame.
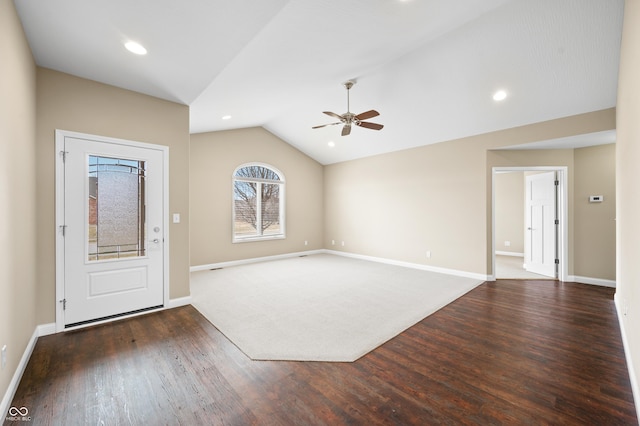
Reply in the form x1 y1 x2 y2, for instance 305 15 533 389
525 172 557 278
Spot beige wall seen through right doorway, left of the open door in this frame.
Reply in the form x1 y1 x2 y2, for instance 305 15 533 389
494 172 525 254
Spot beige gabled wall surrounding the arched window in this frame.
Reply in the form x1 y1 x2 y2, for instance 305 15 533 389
190 128 323 266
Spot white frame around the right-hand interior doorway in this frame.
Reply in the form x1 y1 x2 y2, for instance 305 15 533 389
490 166 569 281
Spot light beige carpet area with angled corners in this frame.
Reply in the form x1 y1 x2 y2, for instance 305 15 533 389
191 254 481 362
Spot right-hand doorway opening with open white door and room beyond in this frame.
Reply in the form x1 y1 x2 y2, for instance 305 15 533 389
491 166 569 281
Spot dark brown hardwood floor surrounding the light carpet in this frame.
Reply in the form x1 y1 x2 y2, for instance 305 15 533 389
5 280 638 425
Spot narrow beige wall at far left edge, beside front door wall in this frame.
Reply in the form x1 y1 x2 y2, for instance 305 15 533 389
0 0 38 408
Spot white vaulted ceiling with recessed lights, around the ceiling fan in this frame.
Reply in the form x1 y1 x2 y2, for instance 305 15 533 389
15 0 624 164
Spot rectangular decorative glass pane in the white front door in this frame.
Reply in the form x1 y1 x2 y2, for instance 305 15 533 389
88 156 145 260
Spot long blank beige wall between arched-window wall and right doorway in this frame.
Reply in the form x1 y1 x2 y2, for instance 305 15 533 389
325 135 486 273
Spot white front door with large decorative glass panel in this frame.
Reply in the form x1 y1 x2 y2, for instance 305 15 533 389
57 134 167 327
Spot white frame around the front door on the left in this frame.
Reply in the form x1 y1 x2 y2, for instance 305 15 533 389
55 129 170 332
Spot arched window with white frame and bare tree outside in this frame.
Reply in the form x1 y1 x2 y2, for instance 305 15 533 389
233 163 285 242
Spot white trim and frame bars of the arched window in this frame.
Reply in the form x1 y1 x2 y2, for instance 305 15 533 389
231 162 285 243
